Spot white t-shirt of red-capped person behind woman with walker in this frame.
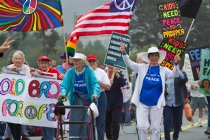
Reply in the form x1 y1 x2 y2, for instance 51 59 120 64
94 68 110 92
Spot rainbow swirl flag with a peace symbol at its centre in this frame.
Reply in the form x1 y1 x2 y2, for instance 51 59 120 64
0 0 63 32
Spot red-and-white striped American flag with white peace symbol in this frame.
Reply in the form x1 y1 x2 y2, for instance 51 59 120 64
67 0 136 57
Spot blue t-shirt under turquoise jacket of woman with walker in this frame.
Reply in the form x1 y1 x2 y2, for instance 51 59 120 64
74 72 88 94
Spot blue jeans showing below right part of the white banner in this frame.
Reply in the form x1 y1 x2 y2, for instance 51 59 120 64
42 127 56 140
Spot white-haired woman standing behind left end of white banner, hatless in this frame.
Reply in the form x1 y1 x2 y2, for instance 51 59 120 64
5 50 31 140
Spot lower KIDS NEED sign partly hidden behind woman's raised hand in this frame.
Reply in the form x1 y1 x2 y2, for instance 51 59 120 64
160 38 186 70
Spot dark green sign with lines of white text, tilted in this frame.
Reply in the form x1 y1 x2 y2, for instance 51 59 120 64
104 32 131 69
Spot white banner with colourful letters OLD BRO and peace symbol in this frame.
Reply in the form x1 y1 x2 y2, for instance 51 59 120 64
0 74 69 128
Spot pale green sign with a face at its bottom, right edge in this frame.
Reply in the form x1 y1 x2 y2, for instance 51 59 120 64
199 50 210 96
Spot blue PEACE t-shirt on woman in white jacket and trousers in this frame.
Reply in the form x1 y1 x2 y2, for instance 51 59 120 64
140 66 162 106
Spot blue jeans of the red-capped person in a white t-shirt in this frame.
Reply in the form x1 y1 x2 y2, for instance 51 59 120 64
96 92 107 140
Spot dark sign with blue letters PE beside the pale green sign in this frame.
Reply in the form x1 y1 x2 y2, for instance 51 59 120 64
188 47 210 81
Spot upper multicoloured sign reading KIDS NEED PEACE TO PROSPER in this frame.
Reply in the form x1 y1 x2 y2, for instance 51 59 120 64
158 1 184 38
